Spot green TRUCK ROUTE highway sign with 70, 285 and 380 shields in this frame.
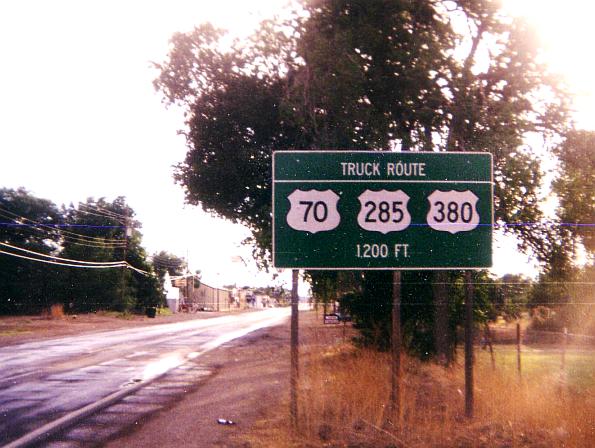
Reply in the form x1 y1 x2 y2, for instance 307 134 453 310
273 151 493 270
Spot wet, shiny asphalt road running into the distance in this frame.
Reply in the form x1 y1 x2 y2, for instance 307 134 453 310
0 308 290 446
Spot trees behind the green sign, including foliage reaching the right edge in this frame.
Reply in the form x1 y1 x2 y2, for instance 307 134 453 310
154 0 595 359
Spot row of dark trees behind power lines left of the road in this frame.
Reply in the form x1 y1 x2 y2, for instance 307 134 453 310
0 188 186 315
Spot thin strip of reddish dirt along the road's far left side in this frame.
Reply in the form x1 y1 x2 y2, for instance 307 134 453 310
0 312 237 347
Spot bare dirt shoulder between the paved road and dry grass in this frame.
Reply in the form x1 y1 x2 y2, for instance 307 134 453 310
107 312 351 448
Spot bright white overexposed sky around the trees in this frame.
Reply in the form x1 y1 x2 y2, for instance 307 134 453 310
0 0 595 285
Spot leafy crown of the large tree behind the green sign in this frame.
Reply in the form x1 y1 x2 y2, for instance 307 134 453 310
155 0 566 356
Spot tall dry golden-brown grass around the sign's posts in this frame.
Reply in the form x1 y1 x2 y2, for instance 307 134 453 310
243 316 595 448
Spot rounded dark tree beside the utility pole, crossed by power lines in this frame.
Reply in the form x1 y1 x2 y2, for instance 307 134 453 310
61 197 162 311
